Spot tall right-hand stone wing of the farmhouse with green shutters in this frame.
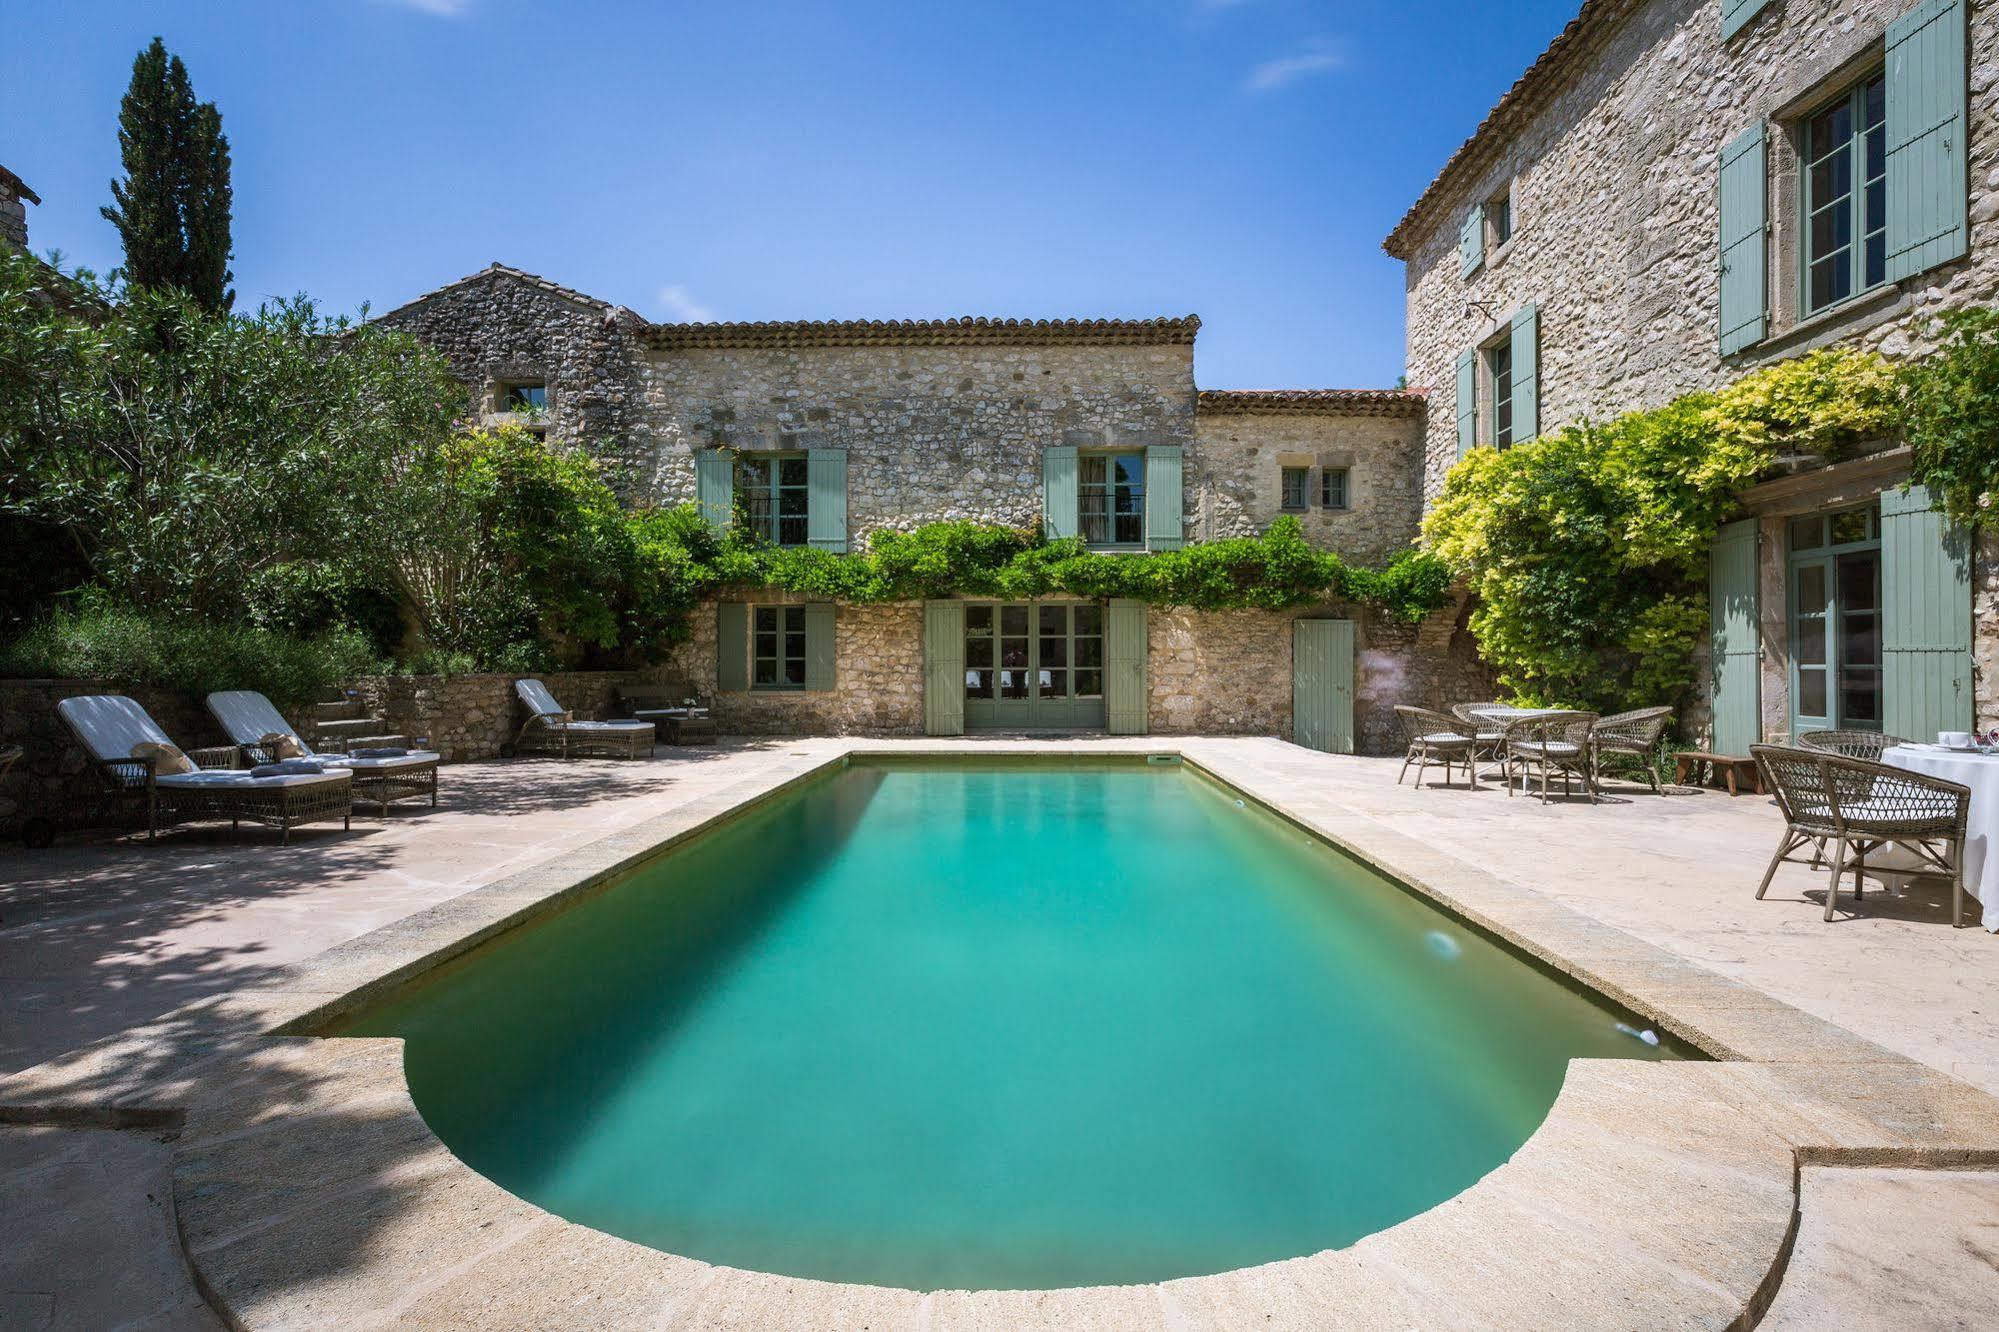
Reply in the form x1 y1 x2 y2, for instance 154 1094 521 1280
1385 0 1999 754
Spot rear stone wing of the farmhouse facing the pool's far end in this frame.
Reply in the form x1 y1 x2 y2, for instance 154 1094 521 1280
382 274 1491 752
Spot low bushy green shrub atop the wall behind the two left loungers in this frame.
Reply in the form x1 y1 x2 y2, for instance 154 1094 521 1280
0 606 382 708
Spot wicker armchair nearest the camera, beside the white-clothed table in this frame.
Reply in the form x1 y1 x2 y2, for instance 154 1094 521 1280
1749 744 1971 926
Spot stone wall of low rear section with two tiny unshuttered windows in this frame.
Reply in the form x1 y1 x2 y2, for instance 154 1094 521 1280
1189 396 1423 564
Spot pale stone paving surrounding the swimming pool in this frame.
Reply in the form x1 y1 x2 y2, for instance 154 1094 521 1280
0 740 1999 1326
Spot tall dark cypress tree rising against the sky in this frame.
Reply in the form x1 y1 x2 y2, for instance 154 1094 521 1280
102 38 236 312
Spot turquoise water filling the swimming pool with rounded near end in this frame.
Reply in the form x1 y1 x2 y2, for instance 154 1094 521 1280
346 762 1669 1290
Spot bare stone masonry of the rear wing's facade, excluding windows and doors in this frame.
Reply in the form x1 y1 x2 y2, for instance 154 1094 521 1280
375 266 1491 756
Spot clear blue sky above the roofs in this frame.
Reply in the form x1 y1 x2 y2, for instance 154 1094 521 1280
0 0 1575 388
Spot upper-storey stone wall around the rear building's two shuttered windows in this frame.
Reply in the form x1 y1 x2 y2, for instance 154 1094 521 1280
646 344 1201 542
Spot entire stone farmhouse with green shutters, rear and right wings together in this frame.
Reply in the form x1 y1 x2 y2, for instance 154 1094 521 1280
371 0 1999 752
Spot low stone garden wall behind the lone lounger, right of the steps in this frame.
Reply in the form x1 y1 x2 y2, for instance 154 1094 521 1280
356 670 672 764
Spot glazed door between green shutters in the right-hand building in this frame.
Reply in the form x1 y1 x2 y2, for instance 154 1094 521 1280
1791 504 1881 738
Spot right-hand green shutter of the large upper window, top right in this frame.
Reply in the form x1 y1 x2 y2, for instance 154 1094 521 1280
1887 0 1971 282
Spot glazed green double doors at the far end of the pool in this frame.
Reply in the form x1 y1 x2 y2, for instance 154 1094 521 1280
960 602 1105 730
